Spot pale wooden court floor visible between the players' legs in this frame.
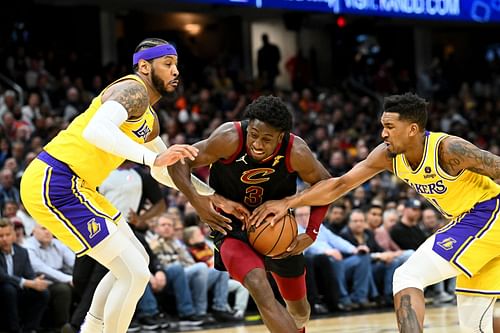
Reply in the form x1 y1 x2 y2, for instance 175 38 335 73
177 305 500 333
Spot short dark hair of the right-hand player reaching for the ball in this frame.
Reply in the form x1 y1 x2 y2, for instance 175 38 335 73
384 93 429 130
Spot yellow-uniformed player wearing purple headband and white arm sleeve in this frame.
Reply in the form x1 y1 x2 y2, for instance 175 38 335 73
21 39 236 333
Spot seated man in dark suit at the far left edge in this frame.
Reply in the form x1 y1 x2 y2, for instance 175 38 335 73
0 218 49 333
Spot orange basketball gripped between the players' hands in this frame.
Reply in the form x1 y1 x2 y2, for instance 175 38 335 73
247 214 297 257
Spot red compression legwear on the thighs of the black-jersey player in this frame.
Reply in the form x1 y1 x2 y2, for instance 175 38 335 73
220 237 306 301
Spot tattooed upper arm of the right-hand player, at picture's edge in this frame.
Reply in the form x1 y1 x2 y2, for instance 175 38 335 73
439 136 500 179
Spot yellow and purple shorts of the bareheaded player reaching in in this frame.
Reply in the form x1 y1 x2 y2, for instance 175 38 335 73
433 196 500 296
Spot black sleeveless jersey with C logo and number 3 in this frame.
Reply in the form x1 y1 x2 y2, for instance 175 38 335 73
209 121 297 234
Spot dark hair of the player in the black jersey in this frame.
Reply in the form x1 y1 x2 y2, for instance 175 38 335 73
245 96 293 132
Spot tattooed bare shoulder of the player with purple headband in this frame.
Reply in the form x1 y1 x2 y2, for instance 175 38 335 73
111 82 149 117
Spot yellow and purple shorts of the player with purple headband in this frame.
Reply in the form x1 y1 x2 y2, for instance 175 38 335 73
21 152 121 256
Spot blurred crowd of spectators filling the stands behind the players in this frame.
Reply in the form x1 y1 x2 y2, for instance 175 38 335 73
0 42 500 332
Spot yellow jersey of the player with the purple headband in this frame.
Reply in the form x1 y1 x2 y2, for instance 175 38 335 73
44 75 155 188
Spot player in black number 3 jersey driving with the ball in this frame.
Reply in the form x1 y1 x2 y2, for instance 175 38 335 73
169 96 329 333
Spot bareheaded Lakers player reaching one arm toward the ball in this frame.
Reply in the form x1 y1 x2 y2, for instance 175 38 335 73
250 93 500 332
